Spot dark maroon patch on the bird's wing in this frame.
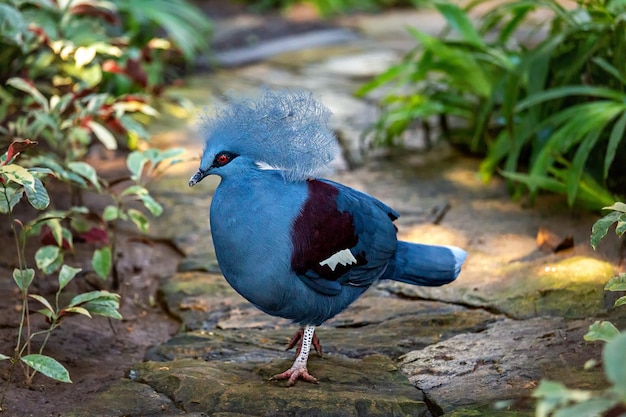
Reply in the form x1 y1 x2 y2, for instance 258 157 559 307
291 180 366 279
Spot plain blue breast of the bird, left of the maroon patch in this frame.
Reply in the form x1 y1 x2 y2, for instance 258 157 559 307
210 176 306 309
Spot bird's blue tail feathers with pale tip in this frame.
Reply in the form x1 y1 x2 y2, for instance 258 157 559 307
383 241 467 287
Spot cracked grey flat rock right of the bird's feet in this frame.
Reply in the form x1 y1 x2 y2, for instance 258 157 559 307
400 318 606 412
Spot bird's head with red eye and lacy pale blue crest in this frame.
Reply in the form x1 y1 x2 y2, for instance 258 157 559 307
189 90 338 186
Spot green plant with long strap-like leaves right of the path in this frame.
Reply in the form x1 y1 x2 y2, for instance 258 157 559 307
358 0 626 208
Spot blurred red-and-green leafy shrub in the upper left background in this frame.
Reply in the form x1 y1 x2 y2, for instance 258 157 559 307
0 0 195 288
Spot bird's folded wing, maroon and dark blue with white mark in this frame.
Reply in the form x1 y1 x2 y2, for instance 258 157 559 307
292 180 398 295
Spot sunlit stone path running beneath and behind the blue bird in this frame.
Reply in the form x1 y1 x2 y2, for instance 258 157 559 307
70 4 617 417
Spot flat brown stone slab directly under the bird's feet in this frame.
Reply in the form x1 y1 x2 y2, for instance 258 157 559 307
131 356 431 417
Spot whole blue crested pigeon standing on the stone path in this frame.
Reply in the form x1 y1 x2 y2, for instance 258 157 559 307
189 91 465 384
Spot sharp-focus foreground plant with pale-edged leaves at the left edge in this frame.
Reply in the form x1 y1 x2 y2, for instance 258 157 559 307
0 140 121 410
